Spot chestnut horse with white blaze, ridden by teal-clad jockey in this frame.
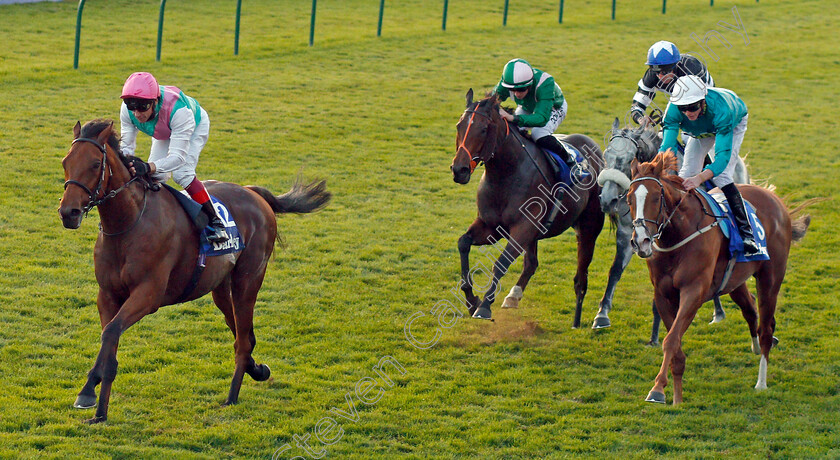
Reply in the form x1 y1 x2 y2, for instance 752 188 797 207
627 151 810 405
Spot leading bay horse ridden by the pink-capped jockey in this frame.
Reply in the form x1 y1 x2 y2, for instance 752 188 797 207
58 119 330 423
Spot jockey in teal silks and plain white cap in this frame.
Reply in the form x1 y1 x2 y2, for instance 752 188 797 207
659 75 759 256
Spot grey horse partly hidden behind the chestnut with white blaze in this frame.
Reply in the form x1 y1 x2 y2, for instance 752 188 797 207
592 118 750 345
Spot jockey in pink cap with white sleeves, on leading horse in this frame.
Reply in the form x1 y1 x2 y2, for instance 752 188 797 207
120 72 228 243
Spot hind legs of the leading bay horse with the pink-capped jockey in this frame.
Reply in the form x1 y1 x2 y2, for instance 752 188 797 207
225 262 271 406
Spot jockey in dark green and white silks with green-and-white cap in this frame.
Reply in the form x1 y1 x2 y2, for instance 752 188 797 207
494 59 576 174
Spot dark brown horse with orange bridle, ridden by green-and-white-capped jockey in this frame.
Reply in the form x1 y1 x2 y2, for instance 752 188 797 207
450 89 604 327
